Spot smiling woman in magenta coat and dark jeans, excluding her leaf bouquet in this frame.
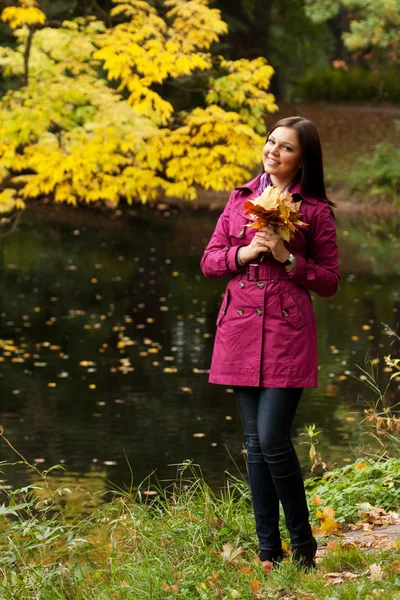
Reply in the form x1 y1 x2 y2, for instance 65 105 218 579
201 117 339 568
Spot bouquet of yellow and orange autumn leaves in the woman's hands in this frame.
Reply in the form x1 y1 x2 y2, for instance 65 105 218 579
243 185 307 242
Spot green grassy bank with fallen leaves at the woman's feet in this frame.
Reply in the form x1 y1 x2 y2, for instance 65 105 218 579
0 446 400 600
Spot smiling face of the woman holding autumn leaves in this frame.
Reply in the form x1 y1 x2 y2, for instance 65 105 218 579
263 127 301 184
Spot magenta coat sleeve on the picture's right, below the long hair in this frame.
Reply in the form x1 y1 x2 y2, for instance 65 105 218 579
287 204 340 297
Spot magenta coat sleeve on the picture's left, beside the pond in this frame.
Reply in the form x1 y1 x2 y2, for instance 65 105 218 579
200 192 243 279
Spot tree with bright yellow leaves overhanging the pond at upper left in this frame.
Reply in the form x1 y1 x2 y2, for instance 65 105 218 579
0 0 276 212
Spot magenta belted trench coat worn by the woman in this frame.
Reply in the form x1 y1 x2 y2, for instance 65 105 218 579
201 175 339 388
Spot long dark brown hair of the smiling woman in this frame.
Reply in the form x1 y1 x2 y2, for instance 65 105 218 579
268 117 335 206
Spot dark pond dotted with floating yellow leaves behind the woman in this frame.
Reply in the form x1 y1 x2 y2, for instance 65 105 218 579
0 206 400 502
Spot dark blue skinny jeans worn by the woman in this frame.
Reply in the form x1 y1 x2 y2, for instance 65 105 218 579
235 387 312 551
